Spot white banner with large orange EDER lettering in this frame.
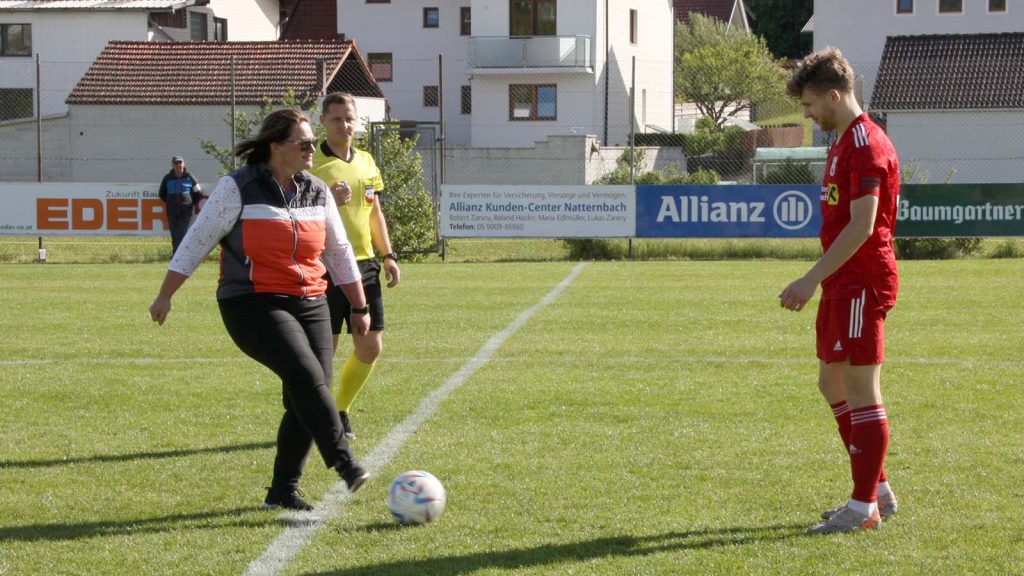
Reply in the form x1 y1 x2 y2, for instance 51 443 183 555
0 182 193 236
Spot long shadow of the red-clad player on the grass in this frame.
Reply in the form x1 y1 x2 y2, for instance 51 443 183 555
305 524 807 576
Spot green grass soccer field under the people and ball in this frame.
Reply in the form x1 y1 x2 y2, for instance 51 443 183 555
0 259 1024 576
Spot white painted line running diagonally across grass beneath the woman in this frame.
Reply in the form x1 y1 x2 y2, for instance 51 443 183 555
239 262 586 576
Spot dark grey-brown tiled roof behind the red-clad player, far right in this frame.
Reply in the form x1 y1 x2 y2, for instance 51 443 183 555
871 32 1024 110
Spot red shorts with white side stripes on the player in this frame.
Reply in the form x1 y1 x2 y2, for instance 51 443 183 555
816 288 892 366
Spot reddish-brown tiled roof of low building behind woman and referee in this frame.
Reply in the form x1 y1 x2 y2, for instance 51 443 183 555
67 41 383 105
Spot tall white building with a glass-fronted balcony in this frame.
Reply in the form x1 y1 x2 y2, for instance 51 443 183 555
338 0 675 148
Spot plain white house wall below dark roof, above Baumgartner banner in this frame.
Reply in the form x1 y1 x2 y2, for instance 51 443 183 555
887 111 1024 183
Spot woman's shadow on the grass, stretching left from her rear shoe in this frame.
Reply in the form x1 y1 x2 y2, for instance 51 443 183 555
0 506 279 542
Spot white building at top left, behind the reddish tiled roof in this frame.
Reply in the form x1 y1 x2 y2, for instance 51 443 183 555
0 0 279 121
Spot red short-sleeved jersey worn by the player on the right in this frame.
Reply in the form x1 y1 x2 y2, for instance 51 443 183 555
820 109 899 306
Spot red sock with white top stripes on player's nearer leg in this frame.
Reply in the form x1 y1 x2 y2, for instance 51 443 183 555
848 404 889 502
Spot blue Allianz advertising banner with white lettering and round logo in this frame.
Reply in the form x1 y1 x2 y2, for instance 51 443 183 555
637 184 821 238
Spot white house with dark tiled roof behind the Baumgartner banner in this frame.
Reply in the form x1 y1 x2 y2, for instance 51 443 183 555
872 32 1024 183
